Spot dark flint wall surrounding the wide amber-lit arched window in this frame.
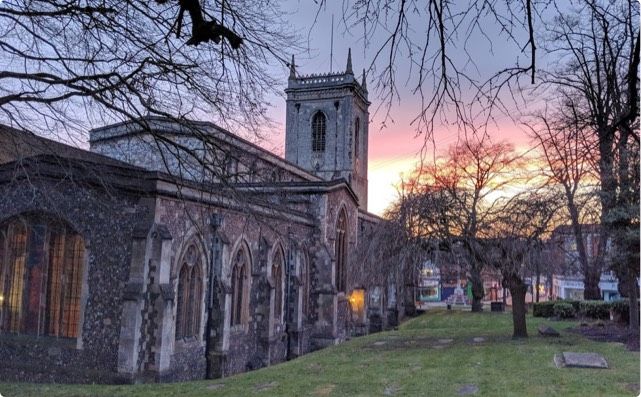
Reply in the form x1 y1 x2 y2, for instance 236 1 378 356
0 172 149 382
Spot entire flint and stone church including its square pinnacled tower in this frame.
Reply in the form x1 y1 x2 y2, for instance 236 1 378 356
0 51 404 383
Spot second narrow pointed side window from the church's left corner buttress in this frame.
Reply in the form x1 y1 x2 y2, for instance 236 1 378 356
231 246 250 326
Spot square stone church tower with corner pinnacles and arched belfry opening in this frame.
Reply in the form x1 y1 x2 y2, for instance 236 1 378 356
285 50 370 210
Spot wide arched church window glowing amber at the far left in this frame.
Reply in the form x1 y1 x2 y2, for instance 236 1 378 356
0 215 85 338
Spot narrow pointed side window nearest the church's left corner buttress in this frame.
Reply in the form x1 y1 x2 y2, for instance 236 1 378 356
176 243 203 339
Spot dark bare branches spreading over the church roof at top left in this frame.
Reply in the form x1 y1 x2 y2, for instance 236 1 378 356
0 0 296 140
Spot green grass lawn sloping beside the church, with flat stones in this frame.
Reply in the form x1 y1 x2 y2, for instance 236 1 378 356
0 311 639 397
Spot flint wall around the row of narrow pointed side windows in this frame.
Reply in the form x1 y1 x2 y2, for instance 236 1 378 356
151 198 320 380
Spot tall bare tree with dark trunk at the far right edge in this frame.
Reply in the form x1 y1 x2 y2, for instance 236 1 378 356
544 0 639 329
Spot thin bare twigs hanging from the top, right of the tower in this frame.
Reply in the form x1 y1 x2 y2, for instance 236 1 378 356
312 0 553 142
